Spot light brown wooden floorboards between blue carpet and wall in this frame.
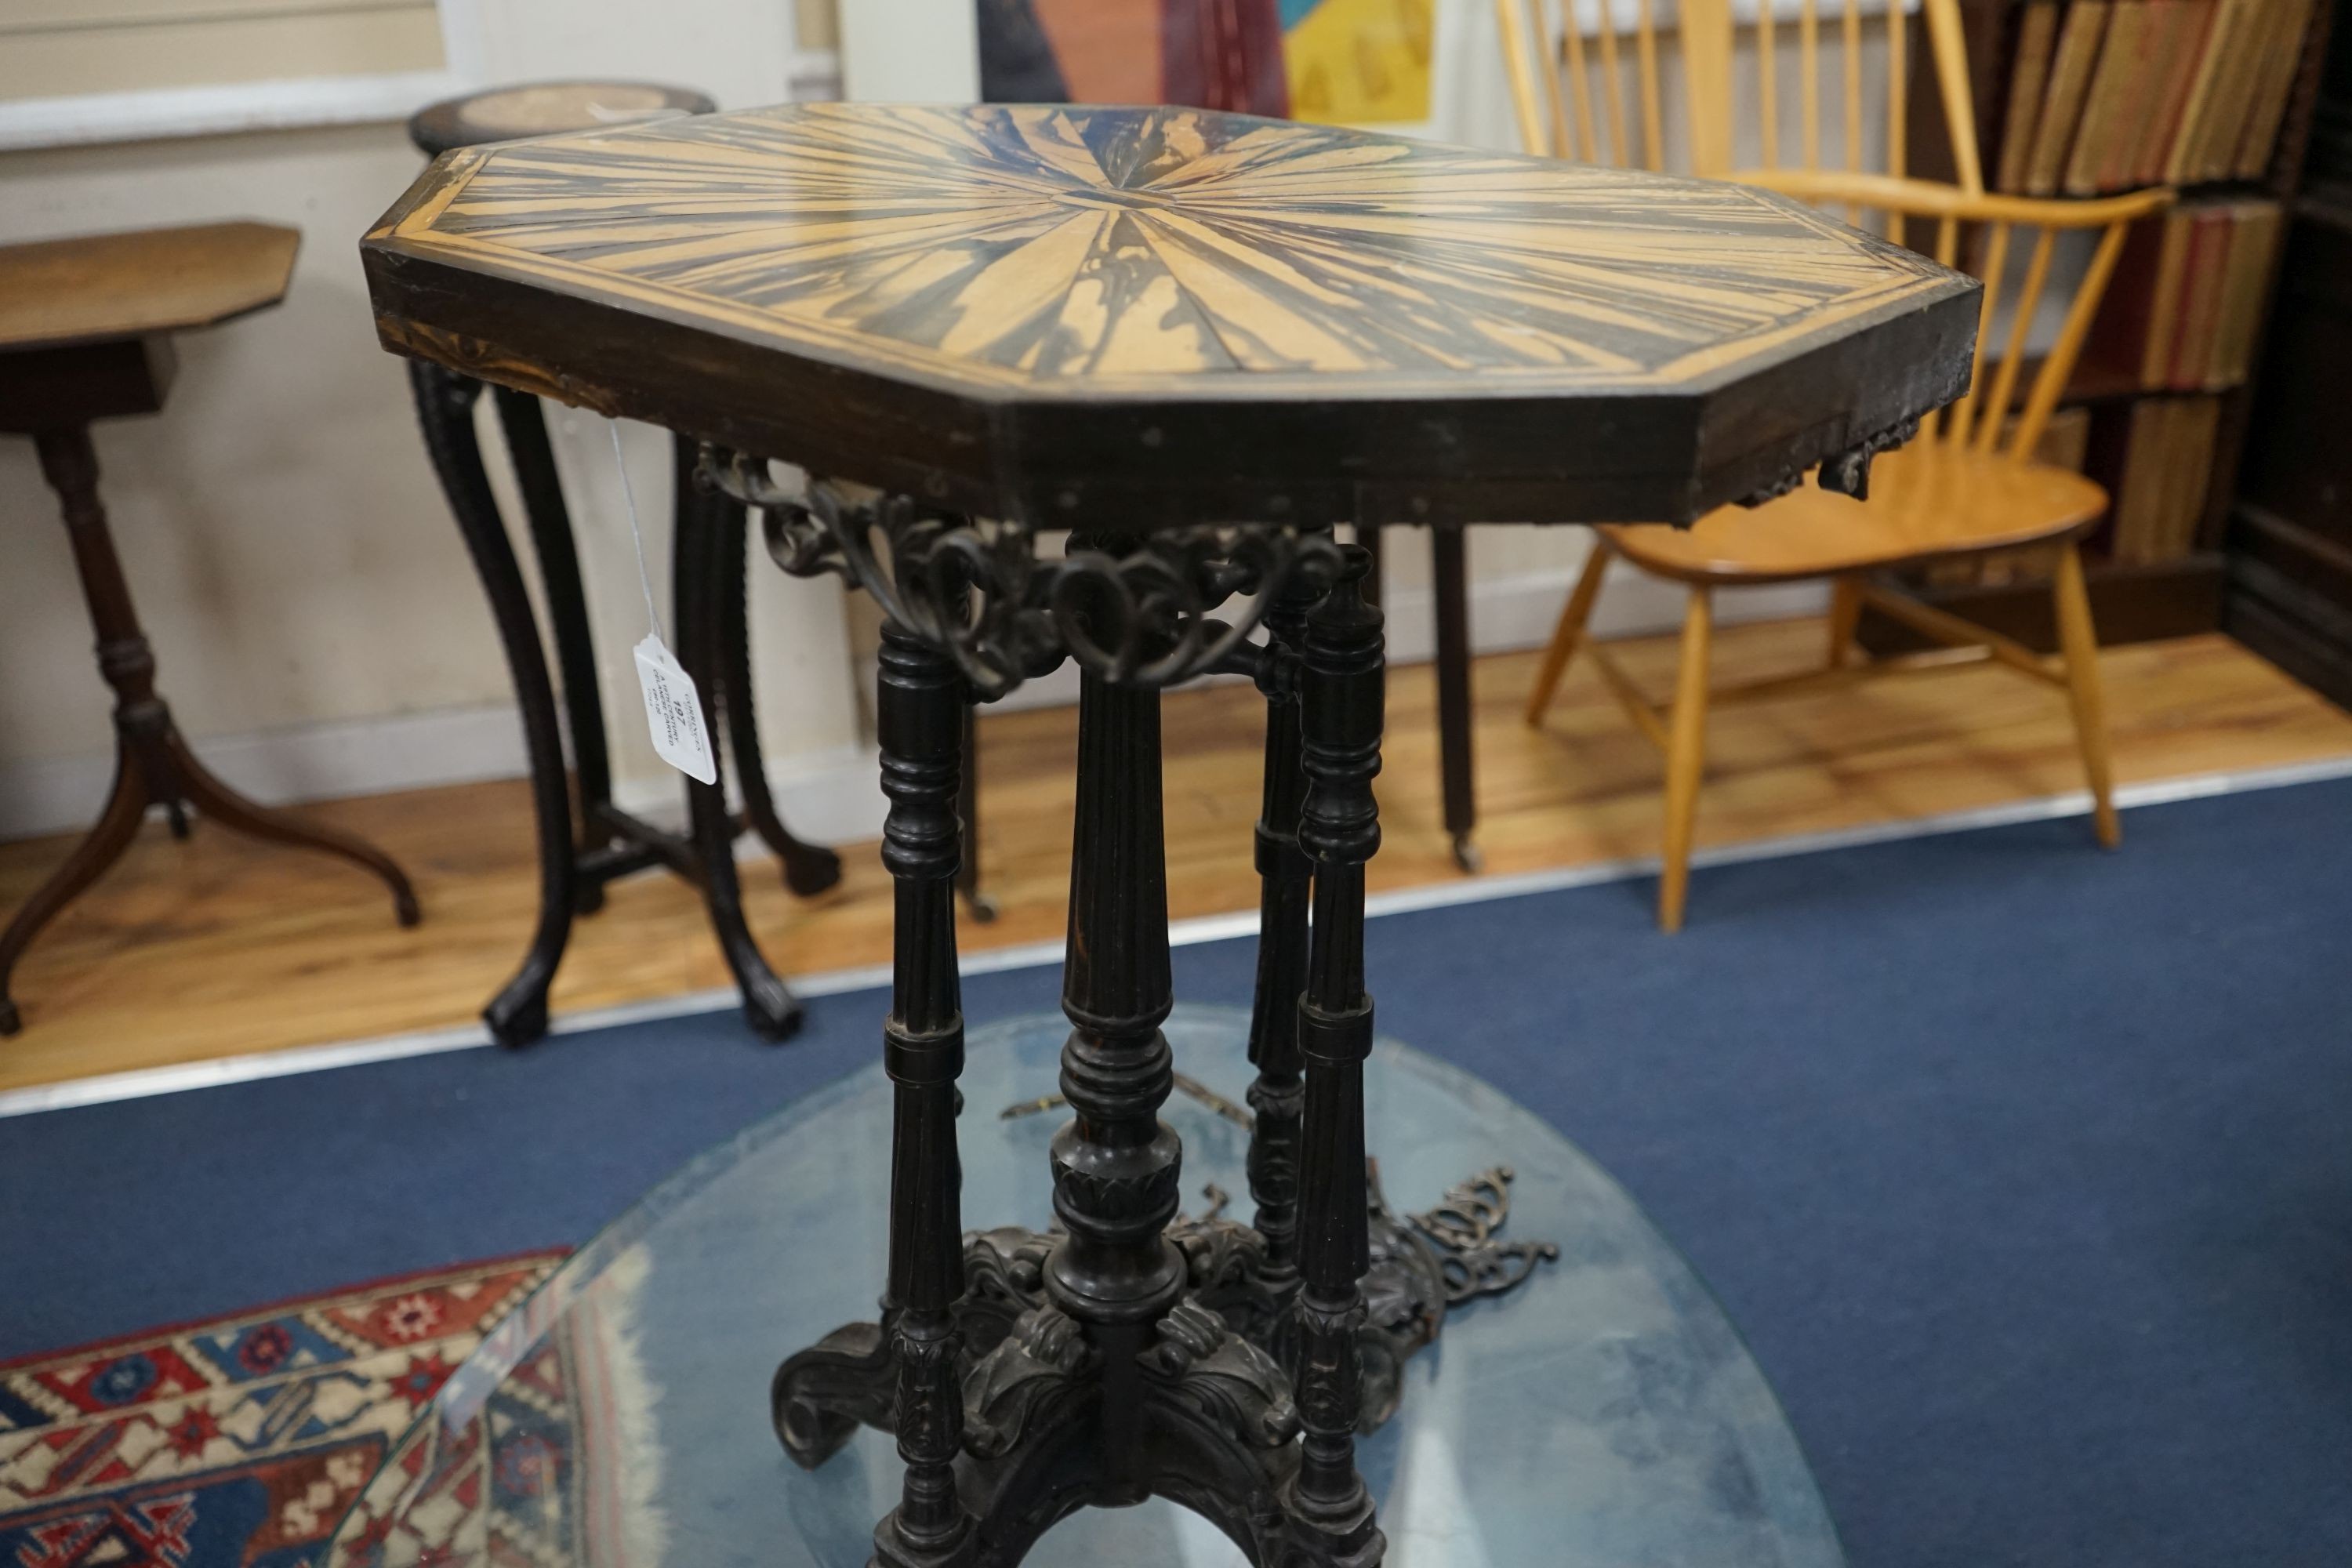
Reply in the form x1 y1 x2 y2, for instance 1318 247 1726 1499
0 623 2352 1088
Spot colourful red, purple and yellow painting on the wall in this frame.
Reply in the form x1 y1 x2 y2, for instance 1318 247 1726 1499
978 0 1435 125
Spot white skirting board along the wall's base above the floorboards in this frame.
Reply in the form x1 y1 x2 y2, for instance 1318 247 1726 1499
0 572 1825 844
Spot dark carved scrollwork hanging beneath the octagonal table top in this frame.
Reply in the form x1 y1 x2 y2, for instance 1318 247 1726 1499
701 447 1338 701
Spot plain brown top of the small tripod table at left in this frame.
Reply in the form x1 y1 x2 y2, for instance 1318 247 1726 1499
0 223 301 353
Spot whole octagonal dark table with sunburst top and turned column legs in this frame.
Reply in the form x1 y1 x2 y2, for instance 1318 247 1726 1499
362 106 1978 1568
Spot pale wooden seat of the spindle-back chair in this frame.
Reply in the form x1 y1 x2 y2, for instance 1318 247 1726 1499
1602 440 2107 583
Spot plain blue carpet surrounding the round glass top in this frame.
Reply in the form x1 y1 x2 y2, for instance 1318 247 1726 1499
0 783 2352 1568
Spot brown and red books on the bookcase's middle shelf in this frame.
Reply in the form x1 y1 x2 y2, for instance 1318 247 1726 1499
2082 198 2284 393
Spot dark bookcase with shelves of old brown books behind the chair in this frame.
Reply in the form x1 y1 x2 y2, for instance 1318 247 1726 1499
1860 0 2352 654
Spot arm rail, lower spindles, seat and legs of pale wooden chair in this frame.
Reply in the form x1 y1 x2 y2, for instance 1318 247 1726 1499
1526 169 2171 931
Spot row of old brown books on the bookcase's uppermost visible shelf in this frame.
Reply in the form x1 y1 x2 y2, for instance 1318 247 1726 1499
1994 0 2312 195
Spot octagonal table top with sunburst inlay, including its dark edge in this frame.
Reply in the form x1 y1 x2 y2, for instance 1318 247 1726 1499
362 103 1978 524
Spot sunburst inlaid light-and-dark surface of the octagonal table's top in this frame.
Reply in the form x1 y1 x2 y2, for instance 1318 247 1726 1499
379 103 1947 395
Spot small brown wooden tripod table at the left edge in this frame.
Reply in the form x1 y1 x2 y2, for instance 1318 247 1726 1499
0 223 416 1034
